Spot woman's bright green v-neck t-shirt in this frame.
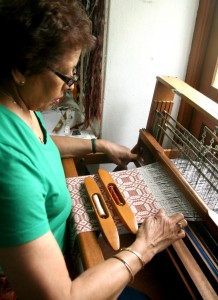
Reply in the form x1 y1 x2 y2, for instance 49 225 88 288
0 105 72 251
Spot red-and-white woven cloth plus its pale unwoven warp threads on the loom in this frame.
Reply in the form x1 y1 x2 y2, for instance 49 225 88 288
66 163 203 233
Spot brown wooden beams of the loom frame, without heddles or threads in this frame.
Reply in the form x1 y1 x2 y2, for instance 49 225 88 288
62 76 218 299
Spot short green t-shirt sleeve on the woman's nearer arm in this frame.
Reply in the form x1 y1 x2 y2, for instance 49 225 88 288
0 144 50 247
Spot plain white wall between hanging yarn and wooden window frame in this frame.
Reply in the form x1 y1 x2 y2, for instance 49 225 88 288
101 0 199 148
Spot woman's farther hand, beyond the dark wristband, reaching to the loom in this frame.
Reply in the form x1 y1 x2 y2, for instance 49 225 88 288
96 140 138 169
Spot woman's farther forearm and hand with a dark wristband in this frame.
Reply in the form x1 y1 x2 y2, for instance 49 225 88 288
51 136 137 167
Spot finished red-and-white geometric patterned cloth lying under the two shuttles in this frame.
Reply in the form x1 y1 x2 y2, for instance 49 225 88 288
67 169 158 233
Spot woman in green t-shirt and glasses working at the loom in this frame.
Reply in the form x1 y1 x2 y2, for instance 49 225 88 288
0 0 187 300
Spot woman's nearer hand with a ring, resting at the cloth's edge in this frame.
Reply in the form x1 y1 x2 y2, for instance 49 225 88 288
131 209 187 262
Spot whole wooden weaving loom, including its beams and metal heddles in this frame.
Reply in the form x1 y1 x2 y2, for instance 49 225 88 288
63 77 218 299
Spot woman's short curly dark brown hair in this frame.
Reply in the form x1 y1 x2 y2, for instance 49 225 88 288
0 0 95 80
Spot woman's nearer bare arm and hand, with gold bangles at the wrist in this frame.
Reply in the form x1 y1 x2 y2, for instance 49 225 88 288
0 210 187 300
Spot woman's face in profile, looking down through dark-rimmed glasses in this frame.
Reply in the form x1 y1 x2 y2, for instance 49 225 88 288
19 50 81 111
